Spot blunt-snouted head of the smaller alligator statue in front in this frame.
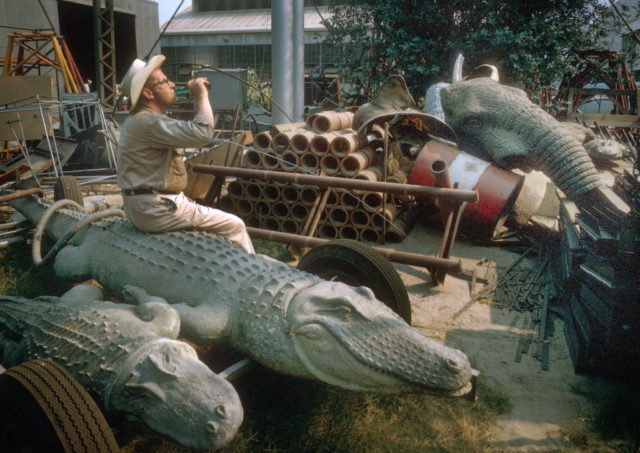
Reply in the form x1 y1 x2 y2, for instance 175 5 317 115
105 338 243 450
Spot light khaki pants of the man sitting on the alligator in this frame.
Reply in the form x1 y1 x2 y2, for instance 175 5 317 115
123 193 254 253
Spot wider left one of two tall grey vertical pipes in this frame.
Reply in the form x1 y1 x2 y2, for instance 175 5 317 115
271 0 293 124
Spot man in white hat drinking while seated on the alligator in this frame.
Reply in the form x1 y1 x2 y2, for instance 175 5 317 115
118 55 254 253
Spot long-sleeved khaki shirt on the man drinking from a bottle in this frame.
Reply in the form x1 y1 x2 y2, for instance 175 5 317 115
118 108 214 192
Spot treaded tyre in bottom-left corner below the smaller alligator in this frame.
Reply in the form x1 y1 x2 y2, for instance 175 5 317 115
0 359 119 453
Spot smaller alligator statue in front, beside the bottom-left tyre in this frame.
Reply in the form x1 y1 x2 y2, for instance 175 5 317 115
0 285 243 449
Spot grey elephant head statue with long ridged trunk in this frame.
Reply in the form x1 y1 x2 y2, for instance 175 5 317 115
440 77 629 226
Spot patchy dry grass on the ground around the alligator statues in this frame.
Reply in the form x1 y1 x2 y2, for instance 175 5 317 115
0 241 640 453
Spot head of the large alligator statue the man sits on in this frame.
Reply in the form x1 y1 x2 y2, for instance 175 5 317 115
287 282 471 393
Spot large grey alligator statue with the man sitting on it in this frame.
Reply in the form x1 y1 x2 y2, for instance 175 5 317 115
11 196 472 395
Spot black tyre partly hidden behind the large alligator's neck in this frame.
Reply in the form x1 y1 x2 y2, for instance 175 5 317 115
298 239 411 324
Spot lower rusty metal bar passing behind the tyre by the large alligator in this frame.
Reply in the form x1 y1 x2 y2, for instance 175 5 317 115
247 227 462 274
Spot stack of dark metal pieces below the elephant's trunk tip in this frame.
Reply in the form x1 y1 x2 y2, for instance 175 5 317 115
559 165 640 379
